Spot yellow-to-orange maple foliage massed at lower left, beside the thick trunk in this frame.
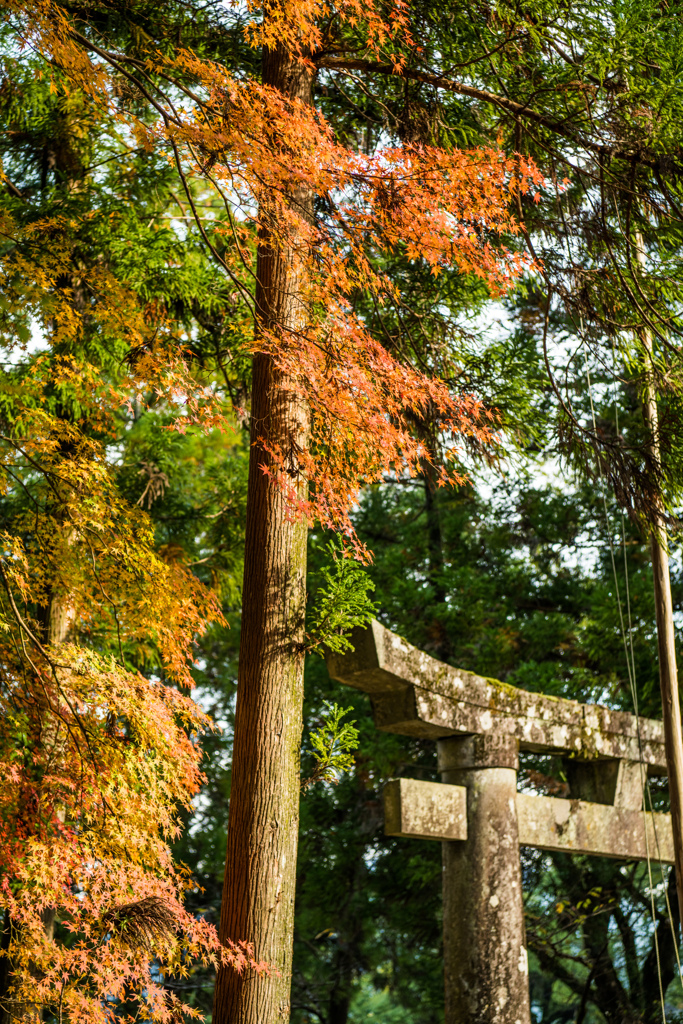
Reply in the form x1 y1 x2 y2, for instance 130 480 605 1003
0 416 261 1022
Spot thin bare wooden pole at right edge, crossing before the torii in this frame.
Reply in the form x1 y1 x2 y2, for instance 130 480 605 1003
636 236 683 920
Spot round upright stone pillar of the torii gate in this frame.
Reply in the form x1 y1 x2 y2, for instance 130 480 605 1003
439 740 530 1024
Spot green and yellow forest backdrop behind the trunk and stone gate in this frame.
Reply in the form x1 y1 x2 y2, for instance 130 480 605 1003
0 0 683 1024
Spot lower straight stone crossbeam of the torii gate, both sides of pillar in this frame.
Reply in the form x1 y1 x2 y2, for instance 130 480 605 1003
384 774 674 864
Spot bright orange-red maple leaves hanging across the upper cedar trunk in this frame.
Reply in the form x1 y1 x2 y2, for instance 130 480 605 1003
2 0 542 534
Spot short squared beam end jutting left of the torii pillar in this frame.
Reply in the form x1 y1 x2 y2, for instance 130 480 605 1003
384 778 467 840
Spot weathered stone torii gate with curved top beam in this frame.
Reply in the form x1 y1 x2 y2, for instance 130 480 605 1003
328 622 674 1024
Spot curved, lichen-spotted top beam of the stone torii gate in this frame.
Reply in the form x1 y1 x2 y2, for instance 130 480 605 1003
328 622 666 774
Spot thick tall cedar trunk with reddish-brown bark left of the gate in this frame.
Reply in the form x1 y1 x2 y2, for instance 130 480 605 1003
213 48 312 1024
